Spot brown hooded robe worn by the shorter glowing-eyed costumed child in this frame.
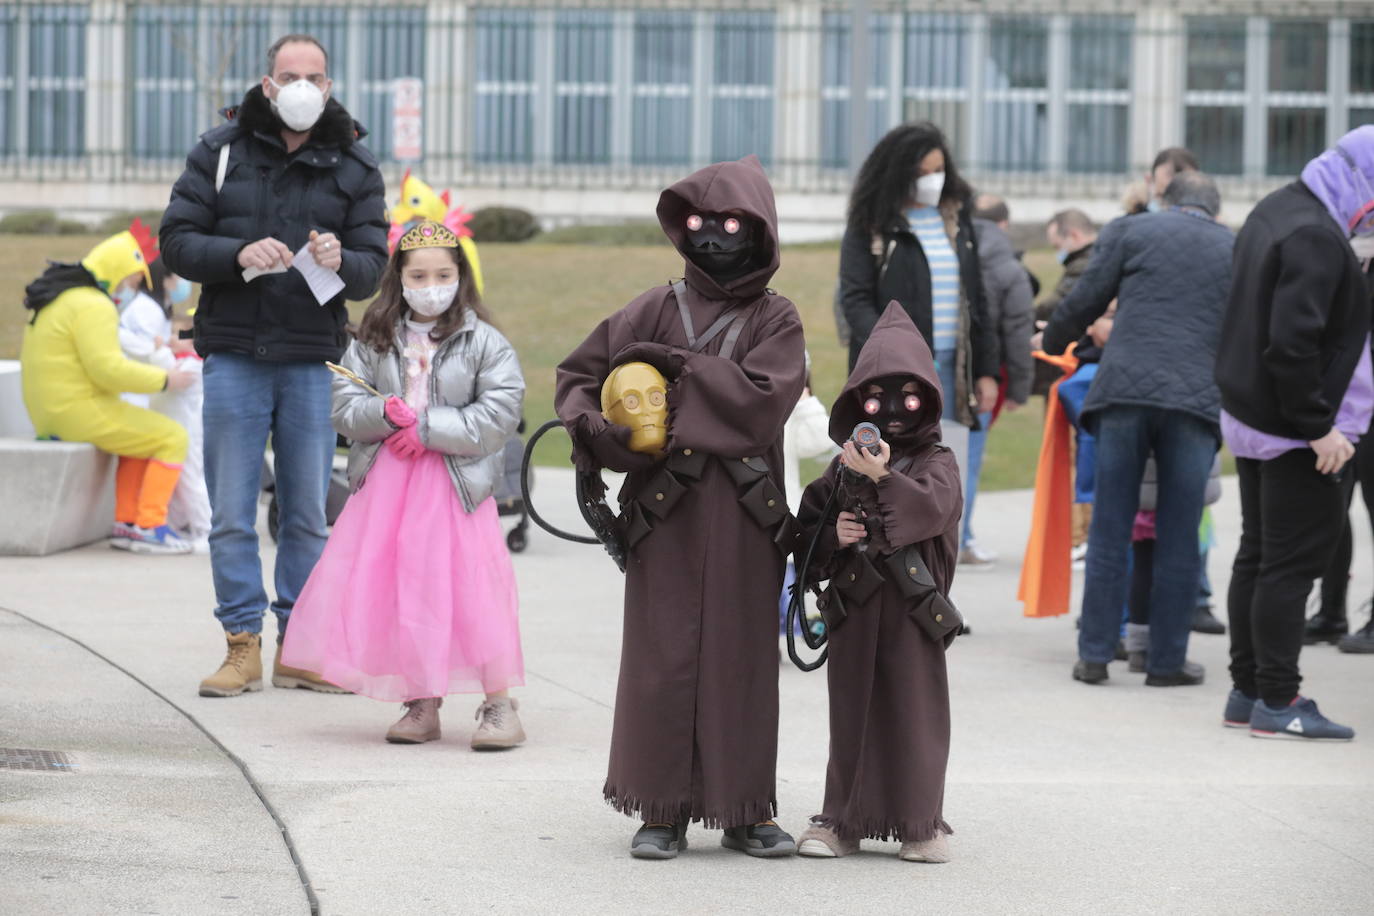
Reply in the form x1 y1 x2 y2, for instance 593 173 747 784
798 302 963 842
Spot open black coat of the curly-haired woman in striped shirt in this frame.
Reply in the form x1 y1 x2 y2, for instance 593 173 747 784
840 206 1000 427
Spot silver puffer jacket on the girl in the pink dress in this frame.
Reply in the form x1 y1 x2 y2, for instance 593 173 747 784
331 312 525 512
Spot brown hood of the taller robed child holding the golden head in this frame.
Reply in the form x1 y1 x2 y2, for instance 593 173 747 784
658 155 779 299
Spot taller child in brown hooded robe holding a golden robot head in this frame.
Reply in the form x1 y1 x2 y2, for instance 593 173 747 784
556 157 805 858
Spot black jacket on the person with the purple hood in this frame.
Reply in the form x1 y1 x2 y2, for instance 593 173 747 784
1220 181 1370 441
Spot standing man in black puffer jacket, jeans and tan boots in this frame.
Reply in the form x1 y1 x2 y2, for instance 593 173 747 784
161 34 387 696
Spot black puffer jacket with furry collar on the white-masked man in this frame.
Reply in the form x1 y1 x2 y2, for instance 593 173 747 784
161 87 387 361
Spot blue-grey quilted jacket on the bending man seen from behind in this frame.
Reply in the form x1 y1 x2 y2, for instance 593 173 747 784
1044 210 1235 438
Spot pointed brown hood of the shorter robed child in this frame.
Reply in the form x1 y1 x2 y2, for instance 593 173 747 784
830 299 944 449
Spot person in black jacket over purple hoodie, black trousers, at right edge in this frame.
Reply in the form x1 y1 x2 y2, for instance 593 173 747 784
1216 125 1374 740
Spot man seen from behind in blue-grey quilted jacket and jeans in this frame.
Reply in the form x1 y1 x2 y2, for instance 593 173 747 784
1032 172 1234 687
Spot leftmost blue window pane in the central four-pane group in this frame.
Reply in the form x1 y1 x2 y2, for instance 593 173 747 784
473 8 534 162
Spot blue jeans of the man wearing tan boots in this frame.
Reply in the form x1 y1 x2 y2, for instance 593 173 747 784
203 353 337 636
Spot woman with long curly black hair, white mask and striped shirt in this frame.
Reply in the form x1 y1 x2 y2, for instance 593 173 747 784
840 122 1000 428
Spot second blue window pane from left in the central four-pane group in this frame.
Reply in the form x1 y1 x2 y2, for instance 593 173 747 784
554 10 611 165
